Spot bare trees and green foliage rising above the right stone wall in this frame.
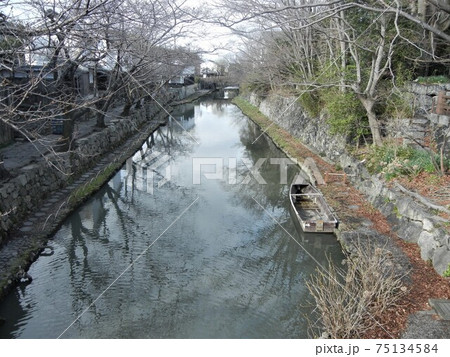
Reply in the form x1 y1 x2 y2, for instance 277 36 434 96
217 0 450 145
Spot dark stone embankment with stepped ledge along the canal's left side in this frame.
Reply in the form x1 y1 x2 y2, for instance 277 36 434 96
0 98 171 298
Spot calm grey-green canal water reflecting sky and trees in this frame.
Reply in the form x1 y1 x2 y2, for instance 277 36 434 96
0 100 342 338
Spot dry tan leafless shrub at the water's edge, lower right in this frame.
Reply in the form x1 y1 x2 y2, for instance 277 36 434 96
307 241 407 338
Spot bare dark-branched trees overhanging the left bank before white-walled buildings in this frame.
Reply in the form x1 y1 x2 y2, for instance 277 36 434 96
0 0 202 172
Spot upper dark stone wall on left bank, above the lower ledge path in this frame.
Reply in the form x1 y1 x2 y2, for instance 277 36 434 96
0 101 165 244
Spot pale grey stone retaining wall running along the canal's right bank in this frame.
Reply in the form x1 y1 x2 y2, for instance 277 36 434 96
246 89 450 275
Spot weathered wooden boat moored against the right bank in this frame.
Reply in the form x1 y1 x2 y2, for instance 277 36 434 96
289 176 339 233
